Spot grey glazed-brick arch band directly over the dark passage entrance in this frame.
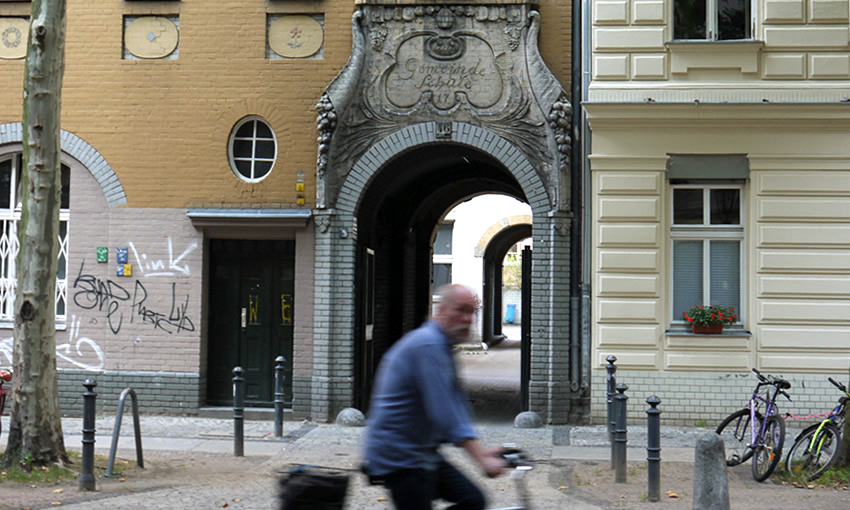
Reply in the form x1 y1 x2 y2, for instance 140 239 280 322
336 122 550 215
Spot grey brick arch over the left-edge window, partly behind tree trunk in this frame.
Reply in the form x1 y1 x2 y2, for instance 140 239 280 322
0 122 127 207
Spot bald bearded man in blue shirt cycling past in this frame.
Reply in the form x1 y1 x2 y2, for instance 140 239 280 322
364 285 507 510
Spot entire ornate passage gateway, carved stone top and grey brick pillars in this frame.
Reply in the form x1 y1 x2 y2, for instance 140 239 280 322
302 1 571 423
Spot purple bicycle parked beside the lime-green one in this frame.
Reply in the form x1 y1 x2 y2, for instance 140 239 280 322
715 368 791 482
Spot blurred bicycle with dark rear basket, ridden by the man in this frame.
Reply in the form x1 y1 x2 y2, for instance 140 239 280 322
280 446 534 510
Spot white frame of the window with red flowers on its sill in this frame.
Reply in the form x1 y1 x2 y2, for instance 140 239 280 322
668 182 747 327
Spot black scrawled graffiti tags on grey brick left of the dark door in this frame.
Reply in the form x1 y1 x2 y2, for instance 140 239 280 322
72 261 195 335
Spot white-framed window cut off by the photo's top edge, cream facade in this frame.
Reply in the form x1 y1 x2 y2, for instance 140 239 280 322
673 0 753 41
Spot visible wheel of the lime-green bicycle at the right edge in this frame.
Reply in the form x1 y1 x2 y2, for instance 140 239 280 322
785 423 841 480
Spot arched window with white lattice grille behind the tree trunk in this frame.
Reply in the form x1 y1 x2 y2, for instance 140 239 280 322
0 153 71 324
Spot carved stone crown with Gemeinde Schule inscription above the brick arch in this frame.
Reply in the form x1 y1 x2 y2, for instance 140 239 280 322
317 3 572 210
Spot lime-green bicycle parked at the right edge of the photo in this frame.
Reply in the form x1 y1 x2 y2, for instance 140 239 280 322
785 377 850 480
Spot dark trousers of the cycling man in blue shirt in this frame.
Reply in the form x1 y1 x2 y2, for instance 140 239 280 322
384 460 485 510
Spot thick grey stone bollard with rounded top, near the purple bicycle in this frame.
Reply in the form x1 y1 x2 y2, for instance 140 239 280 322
693 432 729 510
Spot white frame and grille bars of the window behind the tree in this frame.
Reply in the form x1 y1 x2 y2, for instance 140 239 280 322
0 149 71 329
